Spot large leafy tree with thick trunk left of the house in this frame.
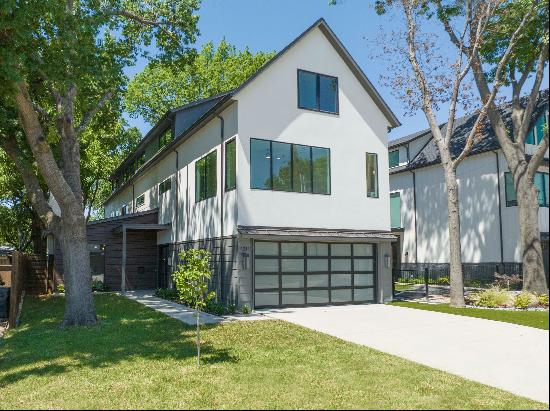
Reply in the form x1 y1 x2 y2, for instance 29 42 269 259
0 0 202 326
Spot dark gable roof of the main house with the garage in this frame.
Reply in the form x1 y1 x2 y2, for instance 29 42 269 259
104 18 401 204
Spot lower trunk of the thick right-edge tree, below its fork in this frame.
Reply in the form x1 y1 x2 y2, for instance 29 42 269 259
515 173 548 293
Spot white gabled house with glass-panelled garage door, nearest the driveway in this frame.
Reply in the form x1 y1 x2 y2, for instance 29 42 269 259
51 19 399 308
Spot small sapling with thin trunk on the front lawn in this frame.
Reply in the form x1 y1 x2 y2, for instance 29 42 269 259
172 248 213 365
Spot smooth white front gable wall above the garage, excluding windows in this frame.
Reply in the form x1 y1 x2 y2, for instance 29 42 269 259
236 29 390 230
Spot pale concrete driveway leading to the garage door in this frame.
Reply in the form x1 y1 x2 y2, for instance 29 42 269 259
263 304 549 403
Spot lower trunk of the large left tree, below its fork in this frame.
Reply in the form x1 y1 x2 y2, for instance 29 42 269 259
61 215 96 327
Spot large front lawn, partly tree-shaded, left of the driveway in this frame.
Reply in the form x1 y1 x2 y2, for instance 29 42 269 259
0 295 548 409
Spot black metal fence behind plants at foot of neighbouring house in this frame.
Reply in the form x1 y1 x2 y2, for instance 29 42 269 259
393 263 522 297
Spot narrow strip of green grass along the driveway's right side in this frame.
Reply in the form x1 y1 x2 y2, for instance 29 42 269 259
391 301 548 330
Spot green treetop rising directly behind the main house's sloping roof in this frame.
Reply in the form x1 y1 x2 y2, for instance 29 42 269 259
125 40 275 124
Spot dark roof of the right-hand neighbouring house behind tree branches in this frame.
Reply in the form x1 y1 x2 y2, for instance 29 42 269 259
390 89 548 174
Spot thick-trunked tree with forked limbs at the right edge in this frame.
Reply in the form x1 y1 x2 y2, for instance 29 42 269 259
434 0 549 293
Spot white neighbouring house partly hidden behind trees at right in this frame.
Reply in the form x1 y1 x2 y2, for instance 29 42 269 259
389 90 550 278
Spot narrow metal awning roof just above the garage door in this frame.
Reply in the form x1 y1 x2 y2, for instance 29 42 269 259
237 225 397 241
